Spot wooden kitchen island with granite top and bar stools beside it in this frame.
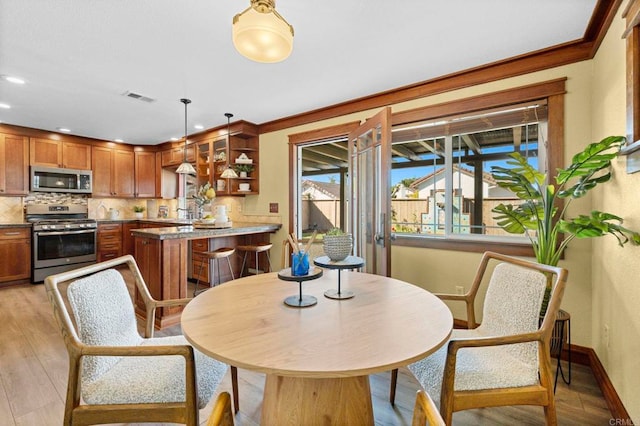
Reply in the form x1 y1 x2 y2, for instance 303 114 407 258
131 222 282 329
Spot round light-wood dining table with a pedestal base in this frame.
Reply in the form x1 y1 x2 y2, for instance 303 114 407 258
182 270 453 426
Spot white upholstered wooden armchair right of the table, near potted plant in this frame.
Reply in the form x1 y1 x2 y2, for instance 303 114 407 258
391 252 567 425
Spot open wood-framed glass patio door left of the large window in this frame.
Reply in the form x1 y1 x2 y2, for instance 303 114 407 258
347 107 391 276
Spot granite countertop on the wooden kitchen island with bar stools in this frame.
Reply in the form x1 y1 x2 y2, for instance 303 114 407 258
131 221 282 240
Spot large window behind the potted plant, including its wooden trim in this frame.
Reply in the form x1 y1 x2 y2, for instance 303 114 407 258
391 80 564 255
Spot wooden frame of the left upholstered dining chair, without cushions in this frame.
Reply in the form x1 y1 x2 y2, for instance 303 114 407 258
44 255 237 426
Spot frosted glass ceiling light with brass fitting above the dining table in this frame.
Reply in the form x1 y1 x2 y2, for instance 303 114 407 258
233 0 293 63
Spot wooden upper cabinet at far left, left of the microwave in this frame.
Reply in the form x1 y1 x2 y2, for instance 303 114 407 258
0 133 31 196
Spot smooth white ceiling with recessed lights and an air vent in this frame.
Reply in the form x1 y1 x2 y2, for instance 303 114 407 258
0 0 596 145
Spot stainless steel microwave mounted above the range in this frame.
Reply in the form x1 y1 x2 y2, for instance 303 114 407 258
31 166 93 194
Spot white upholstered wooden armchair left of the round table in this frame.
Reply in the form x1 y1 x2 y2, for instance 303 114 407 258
45 256 237 425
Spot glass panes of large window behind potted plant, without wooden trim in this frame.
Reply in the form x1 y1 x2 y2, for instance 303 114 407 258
391 100 547 240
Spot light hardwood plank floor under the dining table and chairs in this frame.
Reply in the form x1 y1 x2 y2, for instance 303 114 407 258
0 272 610 426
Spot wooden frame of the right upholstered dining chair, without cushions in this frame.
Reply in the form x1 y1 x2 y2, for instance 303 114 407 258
390 252 568 425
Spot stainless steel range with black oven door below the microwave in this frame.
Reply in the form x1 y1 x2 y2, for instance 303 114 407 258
25 204 98 283
